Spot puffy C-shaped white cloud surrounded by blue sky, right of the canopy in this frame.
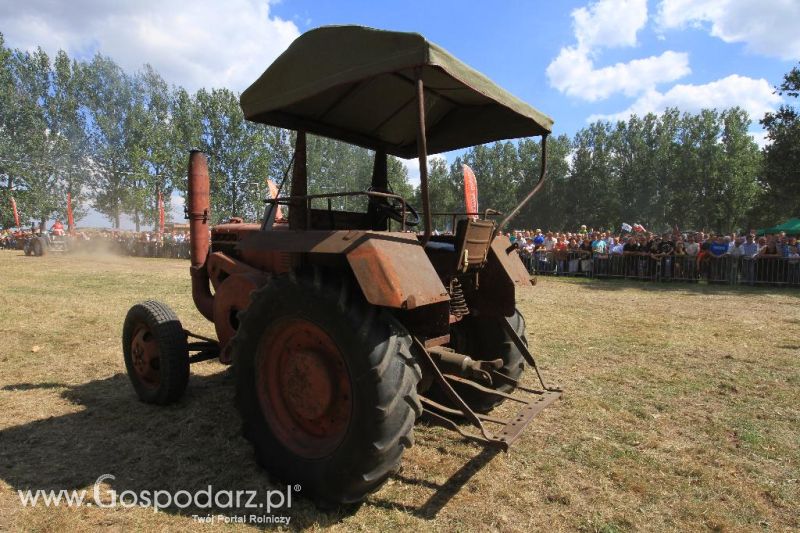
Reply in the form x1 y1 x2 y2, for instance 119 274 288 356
547 0 691 102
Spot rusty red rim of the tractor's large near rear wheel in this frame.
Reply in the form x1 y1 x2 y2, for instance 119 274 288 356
256 318 352 459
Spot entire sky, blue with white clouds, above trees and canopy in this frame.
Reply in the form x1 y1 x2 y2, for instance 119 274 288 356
0 0 800 229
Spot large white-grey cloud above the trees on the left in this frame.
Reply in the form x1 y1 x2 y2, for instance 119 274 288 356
0 0 299 90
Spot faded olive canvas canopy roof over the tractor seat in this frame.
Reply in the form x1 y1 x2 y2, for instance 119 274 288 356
241 26 553 158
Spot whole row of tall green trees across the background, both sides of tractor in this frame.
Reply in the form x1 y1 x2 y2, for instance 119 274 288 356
0 34 800 231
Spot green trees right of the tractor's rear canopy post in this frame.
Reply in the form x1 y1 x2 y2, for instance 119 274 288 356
422 62 800 232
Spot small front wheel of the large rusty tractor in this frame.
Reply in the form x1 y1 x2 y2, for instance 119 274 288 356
122 300 189 405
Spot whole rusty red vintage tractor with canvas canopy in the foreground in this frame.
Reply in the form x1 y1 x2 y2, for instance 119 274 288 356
122 26 561 504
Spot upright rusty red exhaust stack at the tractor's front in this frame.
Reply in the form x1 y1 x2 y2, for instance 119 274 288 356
186 150 214 322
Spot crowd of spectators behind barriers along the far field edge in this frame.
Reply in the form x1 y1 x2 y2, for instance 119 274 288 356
6 221 800 285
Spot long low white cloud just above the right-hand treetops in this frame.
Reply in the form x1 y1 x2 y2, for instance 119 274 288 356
588 74 781 122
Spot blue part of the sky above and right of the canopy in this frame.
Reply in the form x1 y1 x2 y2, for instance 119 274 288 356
272 0 800 139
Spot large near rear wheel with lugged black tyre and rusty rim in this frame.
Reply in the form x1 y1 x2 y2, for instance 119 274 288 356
232 270 422 506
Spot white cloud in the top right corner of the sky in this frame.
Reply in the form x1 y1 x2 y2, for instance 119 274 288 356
658 0 800 60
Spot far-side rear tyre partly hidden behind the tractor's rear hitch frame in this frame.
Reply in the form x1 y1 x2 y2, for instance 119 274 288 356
448 309 528 413
